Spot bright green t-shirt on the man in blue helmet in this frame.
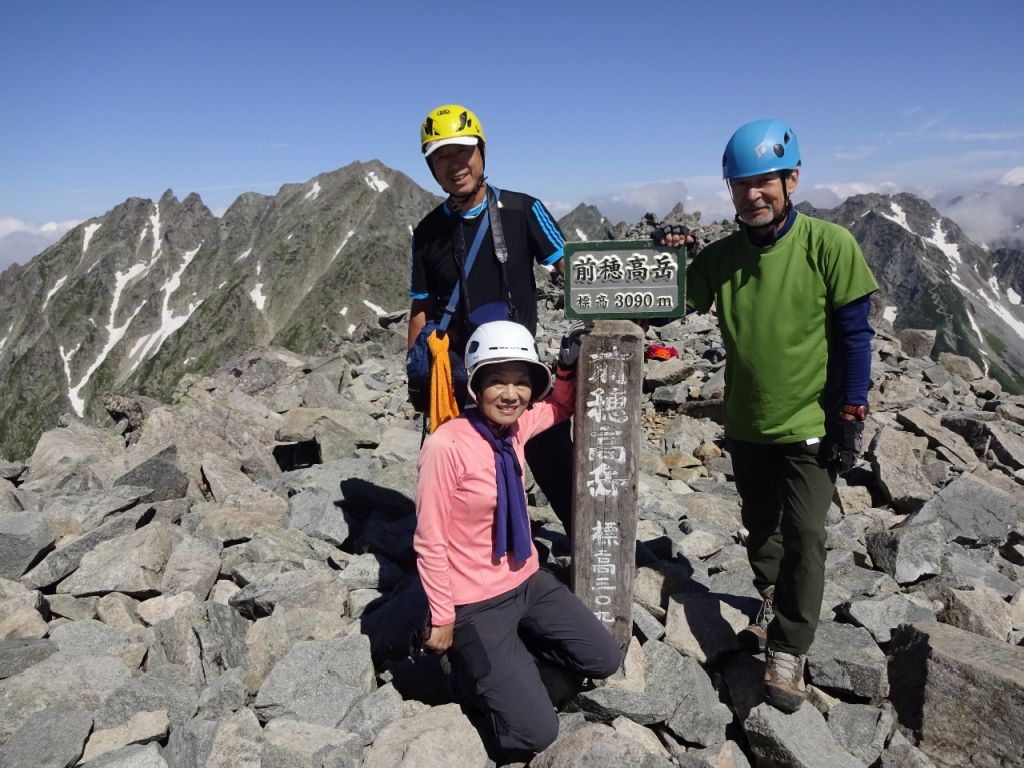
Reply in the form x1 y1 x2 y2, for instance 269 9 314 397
686 214 879 443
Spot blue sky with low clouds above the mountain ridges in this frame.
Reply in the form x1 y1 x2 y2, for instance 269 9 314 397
0 0 1024 268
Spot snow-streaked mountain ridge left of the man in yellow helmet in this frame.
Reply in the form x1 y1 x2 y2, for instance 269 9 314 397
0 161 438 456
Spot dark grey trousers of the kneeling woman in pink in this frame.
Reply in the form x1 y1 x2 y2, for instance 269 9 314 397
451 570 622 753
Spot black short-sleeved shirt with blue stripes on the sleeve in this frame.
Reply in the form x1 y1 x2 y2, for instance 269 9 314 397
409 186 565 351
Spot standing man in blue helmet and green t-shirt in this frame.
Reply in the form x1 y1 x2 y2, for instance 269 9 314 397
655 120 878 712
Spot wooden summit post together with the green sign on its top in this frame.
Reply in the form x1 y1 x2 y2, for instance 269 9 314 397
565 241 686 647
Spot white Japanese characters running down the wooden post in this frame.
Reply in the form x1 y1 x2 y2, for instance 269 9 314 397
585 348 630 624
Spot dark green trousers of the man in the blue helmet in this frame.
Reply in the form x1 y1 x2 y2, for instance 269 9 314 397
729 440 836 653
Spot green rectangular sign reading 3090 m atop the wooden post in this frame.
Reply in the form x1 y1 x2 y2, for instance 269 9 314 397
564 241 686 318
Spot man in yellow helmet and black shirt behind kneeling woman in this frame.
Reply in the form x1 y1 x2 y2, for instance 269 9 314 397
409 104 571 531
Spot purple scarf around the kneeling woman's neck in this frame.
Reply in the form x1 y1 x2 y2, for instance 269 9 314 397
466 408 532 563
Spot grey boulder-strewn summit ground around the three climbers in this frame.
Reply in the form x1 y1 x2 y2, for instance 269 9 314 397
0 299 1024 768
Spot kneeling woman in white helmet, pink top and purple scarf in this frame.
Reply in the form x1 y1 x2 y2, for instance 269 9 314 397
414 321 622 759
